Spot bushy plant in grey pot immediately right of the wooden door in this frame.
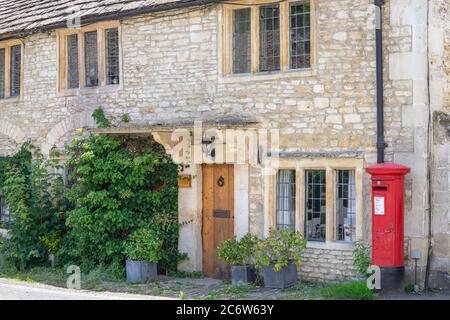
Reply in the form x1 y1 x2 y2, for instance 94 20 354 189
218 233 257 285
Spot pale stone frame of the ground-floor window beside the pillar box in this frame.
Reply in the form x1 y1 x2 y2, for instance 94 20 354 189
264 158 364 247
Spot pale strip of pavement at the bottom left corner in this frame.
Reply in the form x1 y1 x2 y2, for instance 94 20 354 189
0 278 171 300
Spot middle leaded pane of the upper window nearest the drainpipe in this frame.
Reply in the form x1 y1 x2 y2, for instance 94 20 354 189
259 5 280 71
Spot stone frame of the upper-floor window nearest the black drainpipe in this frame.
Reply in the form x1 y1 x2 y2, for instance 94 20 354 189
219 0 317 77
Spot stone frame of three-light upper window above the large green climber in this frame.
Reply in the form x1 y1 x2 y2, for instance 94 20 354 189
56 21 123 94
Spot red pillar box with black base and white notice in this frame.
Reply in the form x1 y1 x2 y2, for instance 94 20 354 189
366 163 411 289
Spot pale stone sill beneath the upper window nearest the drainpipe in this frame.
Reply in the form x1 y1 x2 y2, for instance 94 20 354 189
219 69 317 83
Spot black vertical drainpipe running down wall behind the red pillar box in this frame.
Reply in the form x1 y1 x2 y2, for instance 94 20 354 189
375 0 386 163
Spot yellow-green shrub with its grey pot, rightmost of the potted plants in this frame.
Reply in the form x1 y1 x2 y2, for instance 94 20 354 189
255 229 306 289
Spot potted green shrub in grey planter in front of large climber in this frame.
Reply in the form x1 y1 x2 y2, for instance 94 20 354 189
125 227 163 283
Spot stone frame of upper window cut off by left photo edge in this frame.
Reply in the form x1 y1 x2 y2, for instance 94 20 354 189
0 39 25 101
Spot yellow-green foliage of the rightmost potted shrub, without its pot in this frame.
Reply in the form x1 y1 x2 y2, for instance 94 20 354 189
255 228 306 271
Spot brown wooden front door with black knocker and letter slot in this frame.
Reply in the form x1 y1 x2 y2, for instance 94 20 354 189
202 165 234 279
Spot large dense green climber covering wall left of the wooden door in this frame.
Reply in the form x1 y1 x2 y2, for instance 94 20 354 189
63 109 182 272
